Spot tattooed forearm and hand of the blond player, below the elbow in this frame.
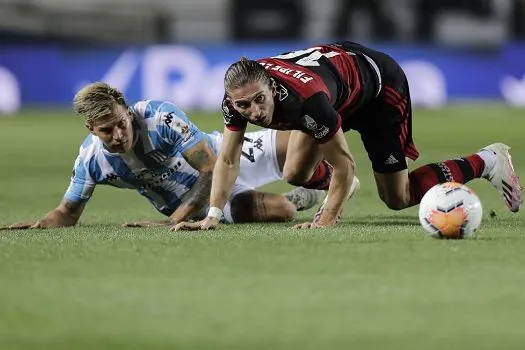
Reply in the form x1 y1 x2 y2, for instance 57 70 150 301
170 172 213 223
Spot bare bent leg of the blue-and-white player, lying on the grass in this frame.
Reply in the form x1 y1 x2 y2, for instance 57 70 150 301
231 190 296 223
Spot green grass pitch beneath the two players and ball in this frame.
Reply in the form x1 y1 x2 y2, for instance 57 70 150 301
0 105 525 350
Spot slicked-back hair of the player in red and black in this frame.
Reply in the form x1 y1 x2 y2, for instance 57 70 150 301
224 57 272 93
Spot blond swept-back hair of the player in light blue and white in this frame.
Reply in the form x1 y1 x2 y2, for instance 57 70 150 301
73 82 127 125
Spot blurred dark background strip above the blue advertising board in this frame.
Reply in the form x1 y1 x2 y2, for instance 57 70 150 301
0 0 525 46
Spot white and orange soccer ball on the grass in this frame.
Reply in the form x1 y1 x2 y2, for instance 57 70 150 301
419 182 483 239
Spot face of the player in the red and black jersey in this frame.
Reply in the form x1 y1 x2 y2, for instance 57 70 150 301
228 82 276 127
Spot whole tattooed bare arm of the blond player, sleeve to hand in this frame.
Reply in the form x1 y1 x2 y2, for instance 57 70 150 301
171 140 217 223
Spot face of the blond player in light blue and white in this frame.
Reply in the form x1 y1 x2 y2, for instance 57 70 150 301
87 105 133 153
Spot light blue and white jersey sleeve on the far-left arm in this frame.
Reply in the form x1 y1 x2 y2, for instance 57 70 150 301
64 152 96 203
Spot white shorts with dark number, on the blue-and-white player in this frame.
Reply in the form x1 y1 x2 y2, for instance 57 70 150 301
205 129 283 223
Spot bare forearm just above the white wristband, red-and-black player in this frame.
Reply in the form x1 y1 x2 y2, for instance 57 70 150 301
210 158 239 209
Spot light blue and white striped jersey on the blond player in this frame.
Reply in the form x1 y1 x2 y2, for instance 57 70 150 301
64 100 216 215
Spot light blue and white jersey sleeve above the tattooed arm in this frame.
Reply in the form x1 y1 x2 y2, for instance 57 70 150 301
152 101 206 153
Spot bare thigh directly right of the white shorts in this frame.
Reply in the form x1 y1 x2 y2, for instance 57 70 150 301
283 130 323 183
